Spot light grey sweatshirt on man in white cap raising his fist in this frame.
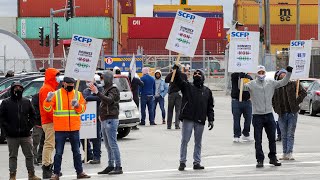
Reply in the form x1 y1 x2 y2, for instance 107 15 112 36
244 72 294 115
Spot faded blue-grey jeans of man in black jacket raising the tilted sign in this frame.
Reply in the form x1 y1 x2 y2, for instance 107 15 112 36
180 120 204 164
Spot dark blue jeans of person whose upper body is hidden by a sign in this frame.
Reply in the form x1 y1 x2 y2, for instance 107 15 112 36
231 99 252 138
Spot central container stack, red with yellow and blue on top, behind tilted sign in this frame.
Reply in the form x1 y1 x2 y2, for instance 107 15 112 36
127 5 225 55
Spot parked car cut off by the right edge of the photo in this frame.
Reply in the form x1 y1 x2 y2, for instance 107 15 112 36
300 79 320 116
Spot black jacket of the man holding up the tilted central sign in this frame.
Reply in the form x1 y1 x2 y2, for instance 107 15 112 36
173 70 214 125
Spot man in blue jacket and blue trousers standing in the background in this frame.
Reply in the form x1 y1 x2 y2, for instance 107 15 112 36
140 67 157 126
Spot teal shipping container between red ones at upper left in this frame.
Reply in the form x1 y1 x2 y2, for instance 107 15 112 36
17 17 113 39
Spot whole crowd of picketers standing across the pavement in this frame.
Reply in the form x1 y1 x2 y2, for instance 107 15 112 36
0 65 306 180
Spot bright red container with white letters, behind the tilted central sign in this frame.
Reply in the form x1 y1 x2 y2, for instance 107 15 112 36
128 17 224 39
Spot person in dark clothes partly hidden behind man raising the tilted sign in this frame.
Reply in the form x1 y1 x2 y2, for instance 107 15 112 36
165 66 188 129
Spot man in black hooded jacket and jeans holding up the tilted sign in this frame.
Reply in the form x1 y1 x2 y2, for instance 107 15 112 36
174 65 214 171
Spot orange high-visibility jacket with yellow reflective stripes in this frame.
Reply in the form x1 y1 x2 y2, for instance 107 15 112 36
43 88 86 132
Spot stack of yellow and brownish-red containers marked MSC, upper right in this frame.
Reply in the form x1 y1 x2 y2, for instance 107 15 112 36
233 0 318 54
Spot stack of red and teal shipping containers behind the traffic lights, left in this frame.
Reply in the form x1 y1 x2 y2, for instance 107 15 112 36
17 0 122 67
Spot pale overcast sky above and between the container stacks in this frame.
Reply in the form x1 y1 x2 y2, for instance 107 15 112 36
0 0 234 25
